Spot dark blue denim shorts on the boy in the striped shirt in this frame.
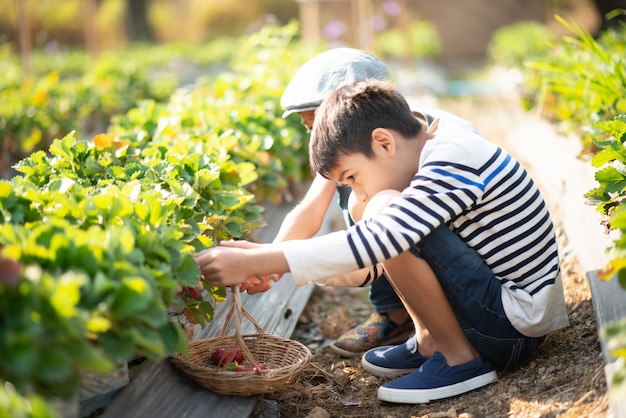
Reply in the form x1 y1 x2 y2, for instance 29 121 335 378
411 225 545 369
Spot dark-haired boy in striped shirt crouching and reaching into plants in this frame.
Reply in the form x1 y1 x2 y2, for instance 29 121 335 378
197 80 568 403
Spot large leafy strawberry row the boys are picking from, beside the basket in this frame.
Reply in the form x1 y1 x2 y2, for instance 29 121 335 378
0 25 314 417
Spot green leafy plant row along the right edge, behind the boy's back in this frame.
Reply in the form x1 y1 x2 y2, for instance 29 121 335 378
492 16 626 401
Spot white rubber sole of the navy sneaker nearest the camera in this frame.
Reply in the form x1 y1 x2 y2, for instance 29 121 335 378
378 370 498 404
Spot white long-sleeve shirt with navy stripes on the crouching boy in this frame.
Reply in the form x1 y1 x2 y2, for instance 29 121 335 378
285 110 568 336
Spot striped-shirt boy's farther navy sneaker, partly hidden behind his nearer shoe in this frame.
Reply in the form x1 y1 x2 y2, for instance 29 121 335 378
361 336 428 377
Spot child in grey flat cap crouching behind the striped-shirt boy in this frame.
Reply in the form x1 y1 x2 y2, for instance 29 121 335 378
274 48 413 357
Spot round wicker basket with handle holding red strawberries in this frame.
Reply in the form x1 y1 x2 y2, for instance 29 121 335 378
170 286 311 396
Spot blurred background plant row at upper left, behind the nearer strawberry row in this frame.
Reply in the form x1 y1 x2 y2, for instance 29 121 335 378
0 32 237 177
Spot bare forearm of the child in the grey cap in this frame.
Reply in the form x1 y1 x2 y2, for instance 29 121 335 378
274 175 337 242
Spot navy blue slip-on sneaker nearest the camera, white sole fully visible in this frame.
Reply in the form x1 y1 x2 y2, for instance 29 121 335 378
378 352 498 404
